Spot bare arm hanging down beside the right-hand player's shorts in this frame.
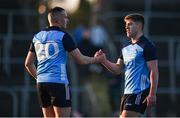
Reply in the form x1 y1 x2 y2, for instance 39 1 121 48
146 60 159 106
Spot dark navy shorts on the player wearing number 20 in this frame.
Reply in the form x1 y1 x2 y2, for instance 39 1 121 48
37 83 71 107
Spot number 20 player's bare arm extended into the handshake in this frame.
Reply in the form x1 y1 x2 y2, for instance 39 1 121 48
70 48 98 64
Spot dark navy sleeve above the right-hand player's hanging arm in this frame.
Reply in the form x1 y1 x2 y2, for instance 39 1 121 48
144 43 157 62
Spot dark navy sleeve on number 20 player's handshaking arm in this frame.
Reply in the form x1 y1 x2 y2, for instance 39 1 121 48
62 33 77 52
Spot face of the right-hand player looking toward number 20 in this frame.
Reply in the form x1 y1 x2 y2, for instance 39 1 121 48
125 19 139 38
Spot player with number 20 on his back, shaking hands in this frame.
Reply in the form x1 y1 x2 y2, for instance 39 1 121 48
25 7 99 117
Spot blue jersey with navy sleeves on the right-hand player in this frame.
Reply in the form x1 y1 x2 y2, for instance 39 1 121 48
120 36 157 94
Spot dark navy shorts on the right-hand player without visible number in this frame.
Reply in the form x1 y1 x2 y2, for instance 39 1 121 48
120 88 149 114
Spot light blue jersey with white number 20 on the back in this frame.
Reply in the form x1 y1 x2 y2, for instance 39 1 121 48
30 26 76 84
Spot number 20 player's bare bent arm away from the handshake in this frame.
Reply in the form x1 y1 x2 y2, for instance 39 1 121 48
25 51 37 79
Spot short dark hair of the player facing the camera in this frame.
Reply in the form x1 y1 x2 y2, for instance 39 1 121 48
124 13 144 26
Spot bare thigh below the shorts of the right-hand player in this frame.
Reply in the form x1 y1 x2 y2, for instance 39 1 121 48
120 110 141 118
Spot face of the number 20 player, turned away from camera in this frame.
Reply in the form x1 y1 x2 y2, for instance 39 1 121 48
60 11 69 29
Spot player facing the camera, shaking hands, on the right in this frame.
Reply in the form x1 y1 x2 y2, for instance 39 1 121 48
96 13 158 117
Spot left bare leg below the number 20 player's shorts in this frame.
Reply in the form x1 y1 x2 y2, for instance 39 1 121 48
42 106 55 118
